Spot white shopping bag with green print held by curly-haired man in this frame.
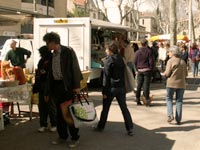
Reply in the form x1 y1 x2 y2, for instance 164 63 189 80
69 95 98 128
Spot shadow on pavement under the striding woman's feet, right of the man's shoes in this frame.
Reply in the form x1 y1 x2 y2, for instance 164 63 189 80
80 122 174 150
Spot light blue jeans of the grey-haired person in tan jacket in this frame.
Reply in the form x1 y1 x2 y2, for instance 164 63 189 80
166 88 185 122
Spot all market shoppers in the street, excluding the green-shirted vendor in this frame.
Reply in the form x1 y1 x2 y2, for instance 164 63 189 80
33 32 197 148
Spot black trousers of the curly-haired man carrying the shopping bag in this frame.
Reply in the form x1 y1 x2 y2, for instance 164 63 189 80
52 80 80 140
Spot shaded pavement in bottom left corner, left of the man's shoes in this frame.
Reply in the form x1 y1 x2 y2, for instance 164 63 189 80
0 117 56 150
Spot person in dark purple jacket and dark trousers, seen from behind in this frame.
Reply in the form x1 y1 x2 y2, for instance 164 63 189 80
134 39 155 106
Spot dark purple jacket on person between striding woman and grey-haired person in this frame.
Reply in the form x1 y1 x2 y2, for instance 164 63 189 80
134 47 155 70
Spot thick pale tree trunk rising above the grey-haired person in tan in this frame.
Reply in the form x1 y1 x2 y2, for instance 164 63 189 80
170 0 177 46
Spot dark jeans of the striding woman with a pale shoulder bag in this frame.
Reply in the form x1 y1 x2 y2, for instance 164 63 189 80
98 88 133 131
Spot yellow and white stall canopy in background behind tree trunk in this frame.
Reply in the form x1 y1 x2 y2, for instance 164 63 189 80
149 34 189 42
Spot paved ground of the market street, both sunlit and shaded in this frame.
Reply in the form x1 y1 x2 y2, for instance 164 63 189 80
0 75 200 150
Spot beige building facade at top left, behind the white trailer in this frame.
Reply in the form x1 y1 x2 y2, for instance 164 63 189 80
0 0 67 44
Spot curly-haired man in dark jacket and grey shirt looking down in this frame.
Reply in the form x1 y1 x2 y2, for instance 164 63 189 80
43 32 83 148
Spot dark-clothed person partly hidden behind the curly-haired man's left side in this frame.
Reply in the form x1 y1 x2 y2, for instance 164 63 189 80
33 46 56 132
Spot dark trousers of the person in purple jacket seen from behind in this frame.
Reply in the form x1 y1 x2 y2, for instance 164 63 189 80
136 71 151 101
